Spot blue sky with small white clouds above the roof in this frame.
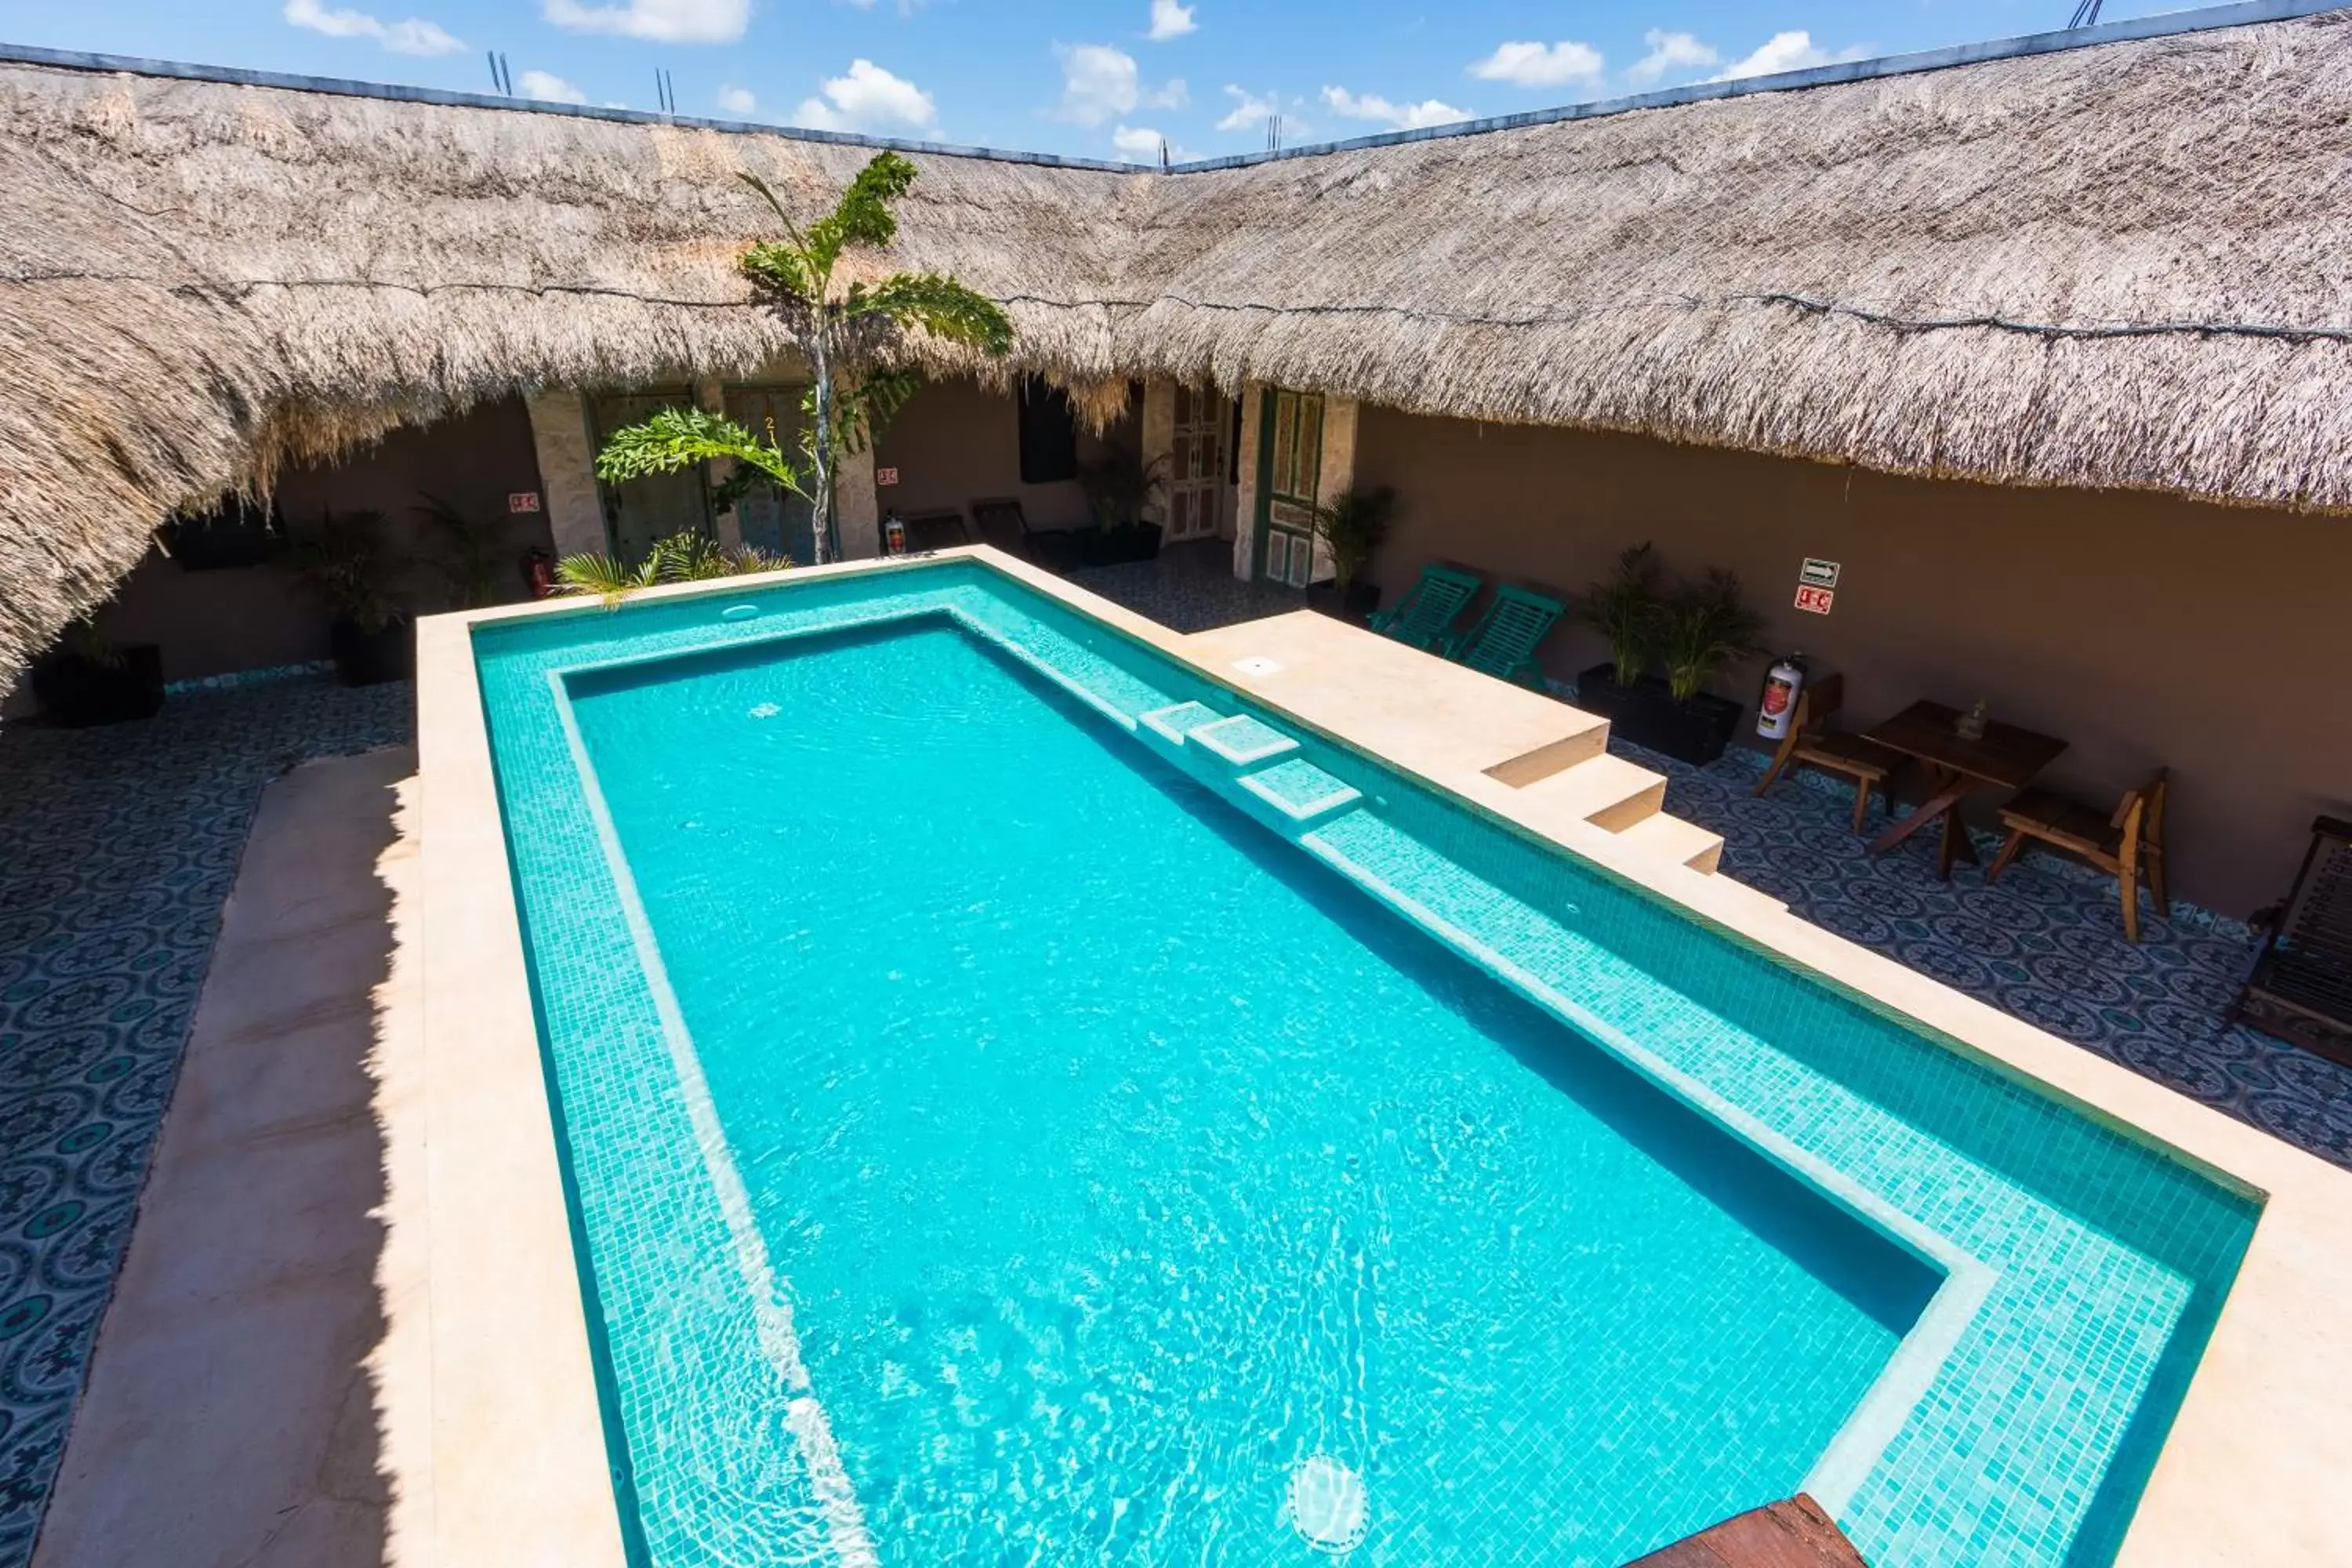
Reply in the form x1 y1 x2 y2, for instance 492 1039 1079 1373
0 0 2176 158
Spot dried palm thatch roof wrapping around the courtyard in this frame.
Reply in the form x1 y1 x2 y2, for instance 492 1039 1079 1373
0 14 2352 677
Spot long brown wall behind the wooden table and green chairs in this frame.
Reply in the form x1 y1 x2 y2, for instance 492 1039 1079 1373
1357 407 2352 914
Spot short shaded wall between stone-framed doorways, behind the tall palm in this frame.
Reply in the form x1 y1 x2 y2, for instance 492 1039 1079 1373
880 381 1138 541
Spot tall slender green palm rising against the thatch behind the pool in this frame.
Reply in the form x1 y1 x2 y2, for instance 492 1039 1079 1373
597 153 1014 564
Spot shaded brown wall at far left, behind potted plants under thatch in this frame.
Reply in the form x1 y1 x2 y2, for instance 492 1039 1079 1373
101 400 548 680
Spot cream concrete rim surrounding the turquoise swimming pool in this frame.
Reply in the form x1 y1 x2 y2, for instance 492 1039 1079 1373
262 550 2352 1568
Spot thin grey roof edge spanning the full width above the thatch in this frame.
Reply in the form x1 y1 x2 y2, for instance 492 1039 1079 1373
0 0 2352 174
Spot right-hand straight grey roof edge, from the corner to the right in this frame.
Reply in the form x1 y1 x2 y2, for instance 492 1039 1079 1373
1169 0 2352 174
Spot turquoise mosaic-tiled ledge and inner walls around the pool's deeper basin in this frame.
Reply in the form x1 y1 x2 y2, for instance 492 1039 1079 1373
477 564 2256 1568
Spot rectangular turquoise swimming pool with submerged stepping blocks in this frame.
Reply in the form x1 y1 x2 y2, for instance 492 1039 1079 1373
475 562 2256 1563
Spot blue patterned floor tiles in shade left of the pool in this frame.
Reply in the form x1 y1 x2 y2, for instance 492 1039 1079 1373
0 680 414 1568
